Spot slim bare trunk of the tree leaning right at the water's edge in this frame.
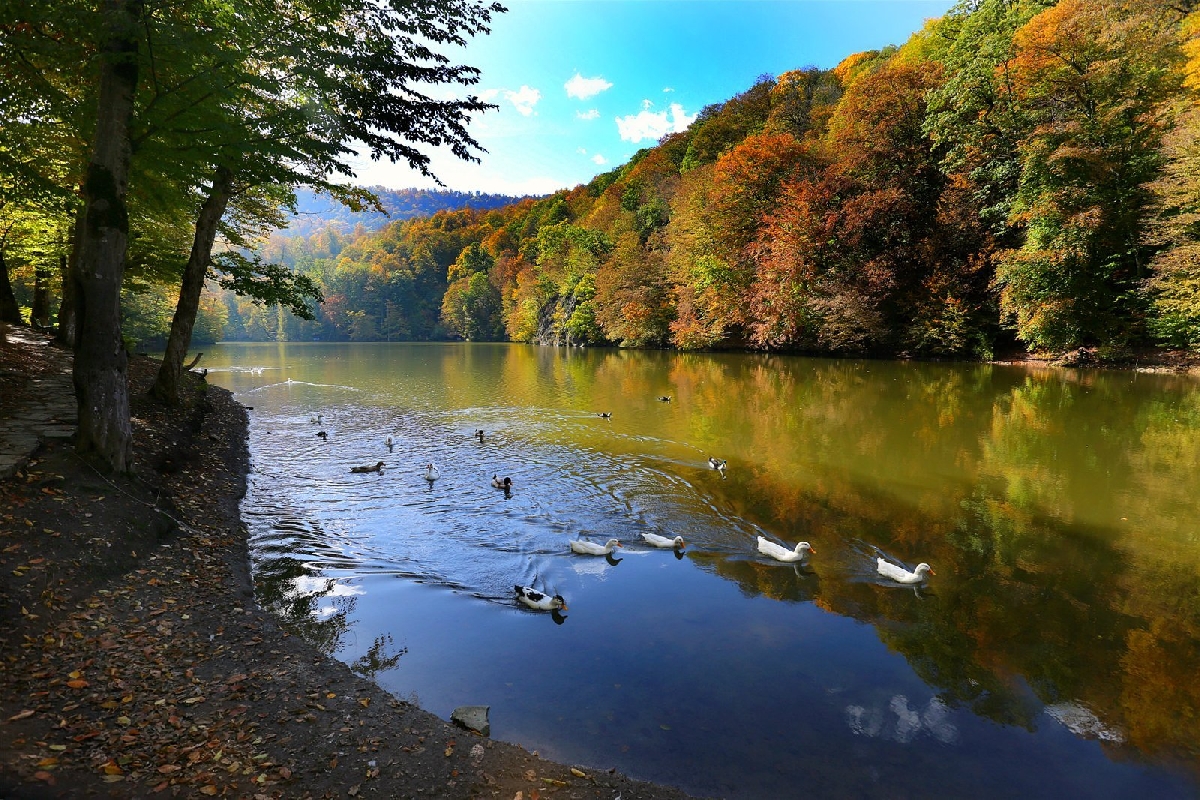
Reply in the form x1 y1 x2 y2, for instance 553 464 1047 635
150 167 233 403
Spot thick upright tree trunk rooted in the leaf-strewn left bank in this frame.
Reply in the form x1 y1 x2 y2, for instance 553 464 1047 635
73 0 143 473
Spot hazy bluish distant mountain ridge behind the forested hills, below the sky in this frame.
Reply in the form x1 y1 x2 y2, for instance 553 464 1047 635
278 186 535 236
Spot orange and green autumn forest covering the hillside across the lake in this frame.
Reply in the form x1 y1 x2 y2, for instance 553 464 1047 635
209 0 1200 357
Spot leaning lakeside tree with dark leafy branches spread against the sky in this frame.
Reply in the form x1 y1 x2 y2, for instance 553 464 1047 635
154 0 503 399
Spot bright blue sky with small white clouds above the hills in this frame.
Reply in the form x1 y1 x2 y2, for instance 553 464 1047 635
355 0 954 194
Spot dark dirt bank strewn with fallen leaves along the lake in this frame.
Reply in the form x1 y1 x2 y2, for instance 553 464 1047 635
0 332 686 800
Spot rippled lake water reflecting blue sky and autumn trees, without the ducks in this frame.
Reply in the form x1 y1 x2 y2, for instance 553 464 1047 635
205 343 1200 799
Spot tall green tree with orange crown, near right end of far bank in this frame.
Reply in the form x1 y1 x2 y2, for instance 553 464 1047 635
996 0 1181 350
